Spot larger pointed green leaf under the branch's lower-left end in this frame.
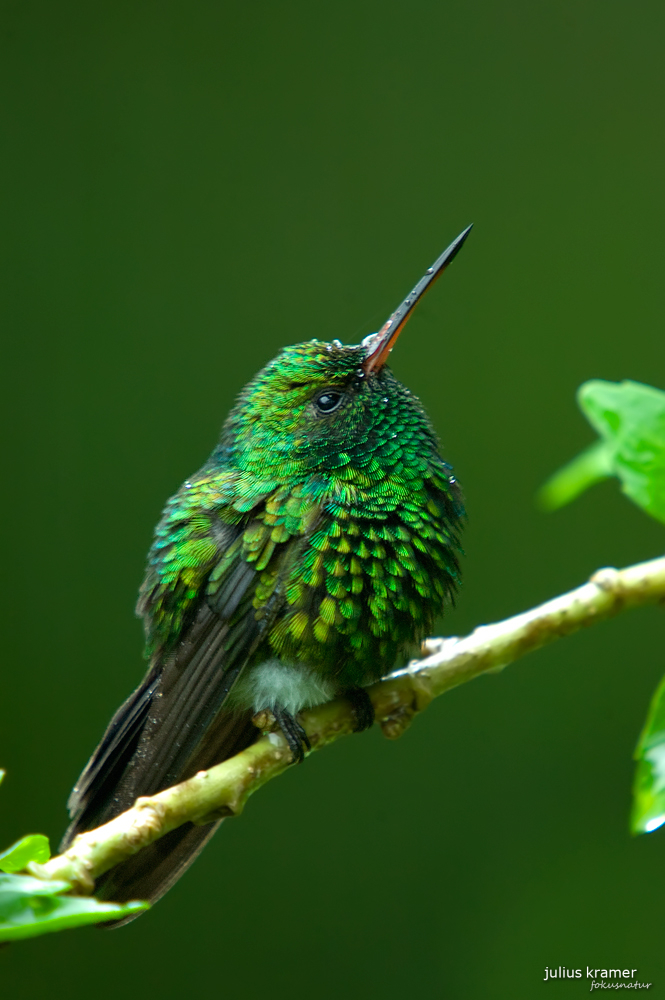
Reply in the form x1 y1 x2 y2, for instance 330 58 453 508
0 872 149 941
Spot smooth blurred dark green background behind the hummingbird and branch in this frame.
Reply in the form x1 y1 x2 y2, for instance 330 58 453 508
0 0 665 1000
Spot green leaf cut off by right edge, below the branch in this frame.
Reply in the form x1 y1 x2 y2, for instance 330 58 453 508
630 677 665 833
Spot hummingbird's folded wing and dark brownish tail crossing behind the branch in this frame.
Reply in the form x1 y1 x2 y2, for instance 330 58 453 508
61 483 315 916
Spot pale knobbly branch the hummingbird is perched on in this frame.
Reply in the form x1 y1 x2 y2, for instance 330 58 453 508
28 558 665 894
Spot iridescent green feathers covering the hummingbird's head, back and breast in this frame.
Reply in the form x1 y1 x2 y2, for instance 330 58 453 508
139 341 461 688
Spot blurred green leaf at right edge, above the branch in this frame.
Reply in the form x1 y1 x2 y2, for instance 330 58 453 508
539 379 665 522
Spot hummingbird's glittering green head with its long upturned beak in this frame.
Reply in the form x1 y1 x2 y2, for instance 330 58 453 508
215 226 471 481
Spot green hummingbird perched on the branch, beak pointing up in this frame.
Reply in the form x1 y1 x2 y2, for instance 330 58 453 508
61 226 471 916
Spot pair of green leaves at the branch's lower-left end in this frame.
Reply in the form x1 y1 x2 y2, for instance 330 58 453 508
0 816 148 941
